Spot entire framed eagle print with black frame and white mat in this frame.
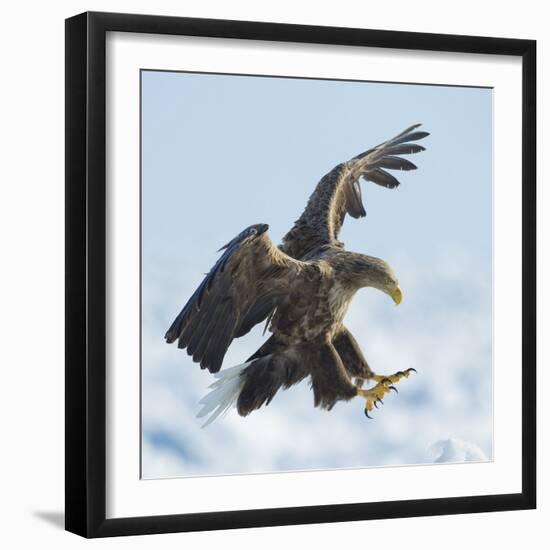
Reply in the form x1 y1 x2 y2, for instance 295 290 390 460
66 13 536 537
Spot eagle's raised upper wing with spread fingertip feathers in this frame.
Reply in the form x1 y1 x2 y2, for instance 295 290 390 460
281 124 429 258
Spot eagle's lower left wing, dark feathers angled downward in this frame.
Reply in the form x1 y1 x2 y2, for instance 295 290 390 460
165 224 312 372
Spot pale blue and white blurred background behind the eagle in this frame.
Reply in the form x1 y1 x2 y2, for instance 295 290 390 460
142 71 492 478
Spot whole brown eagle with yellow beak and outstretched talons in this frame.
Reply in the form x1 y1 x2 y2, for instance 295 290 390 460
165 124 428 426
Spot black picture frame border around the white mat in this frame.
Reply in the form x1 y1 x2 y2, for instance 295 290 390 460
65 12 536 537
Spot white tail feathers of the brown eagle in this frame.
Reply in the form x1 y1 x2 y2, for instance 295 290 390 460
197 361 252 428
